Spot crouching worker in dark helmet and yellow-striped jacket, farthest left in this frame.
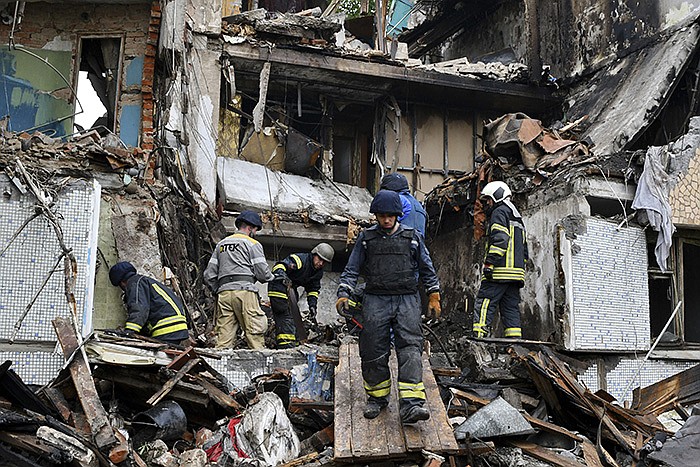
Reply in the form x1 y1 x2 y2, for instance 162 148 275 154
109 261 189 344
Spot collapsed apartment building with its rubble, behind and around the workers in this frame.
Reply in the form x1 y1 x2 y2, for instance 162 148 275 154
0 0 700 466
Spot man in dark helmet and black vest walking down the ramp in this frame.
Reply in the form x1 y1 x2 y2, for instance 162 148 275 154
336 190 441 424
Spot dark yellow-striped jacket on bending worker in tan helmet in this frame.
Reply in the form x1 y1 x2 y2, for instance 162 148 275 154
267 253 323 308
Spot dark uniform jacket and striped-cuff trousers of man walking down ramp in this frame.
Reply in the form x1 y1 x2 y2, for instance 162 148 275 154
338 225 440 410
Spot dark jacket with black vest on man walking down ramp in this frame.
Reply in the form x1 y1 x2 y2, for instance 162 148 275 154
338 224 440 297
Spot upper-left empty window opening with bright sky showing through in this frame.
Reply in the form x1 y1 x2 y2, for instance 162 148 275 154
75 37 121 134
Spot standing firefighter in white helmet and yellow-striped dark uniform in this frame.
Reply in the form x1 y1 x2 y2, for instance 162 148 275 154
474 181 528 338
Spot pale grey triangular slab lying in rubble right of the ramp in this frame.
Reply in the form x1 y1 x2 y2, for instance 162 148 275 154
455 397 535 439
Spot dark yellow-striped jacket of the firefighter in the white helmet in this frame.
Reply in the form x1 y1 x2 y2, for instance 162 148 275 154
484 201 528 284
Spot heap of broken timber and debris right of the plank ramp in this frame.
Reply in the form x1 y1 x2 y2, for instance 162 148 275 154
435 338 698 467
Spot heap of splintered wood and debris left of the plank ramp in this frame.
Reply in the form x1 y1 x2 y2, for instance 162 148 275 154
0 328 332 467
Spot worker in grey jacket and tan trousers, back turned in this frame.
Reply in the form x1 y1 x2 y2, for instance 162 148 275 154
204 211 273 349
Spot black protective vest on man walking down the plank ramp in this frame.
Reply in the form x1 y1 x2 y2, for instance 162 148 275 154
362 228 418 295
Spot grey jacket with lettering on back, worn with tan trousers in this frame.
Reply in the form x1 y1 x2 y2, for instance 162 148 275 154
204 232 274 293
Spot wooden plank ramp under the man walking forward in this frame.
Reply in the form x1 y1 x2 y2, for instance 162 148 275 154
334 343 458 462
